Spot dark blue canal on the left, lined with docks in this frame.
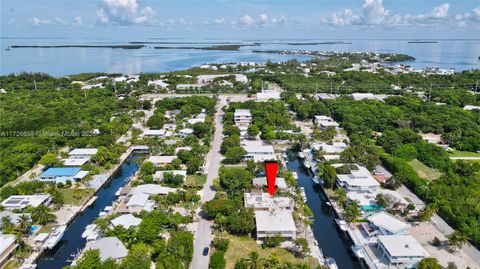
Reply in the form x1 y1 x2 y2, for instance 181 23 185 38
37 155 139 269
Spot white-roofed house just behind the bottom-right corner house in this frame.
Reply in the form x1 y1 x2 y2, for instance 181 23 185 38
367 211 410 235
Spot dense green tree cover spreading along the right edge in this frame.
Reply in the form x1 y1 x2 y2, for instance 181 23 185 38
287 93 480 245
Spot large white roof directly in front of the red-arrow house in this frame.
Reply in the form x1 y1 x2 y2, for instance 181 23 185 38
255 210 297 233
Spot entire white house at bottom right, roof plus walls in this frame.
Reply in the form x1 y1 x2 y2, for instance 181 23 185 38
378 235 428 264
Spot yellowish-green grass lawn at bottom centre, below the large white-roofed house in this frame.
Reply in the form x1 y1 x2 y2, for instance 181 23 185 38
225 236 318 268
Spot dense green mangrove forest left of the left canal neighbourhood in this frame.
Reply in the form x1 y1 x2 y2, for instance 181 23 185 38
0 74 136 185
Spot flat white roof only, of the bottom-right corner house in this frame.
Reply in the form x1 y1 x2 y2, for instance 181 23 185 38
378 235 428 257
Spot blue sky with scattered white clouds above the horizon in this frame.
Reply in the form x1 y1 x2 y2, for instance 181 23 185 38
0 0 480 40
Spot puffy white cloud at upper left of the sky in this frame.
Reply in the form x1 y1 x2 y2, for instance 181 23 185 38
96 0 157 25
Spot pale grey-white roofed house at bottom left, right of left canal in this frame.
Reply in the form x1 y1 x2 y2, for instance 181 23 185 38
86 237 128 261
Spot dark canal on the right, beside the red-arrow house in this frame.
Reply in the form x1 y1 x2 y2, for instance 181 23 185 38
287 154 362 269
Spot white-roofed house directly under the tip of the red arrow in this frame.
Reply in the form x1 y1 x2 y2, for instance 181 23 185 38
243 192 294 210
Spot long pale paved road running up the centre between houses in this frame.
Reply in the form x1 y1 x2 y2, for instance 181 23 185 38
190 97 227 269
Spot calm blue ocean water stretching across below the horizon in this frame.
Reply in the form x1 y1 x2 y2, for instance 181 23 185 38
0 38 480 76
